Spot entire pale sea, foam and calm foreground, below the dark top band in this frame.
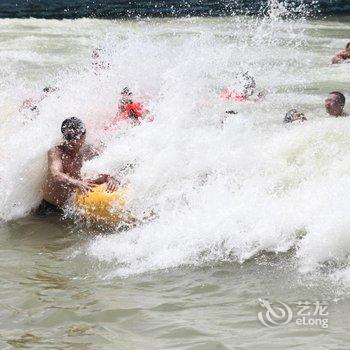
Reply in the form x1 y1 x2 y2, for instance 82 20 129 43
0 14 350 349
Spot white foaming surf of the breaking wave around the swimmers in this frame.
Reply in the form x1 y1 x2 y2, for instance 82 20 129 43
0 10 350 275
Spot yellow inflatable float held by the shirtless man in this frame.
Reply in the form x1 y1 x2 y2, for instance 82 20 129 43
76 184 126 225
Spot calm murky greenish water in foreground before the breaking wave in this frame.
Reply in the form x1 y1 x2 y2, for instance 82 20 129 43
0 218 350 349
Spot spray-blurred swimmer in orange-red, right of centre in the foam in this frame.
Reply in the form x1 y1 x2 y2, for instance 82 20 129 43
220 72 264 102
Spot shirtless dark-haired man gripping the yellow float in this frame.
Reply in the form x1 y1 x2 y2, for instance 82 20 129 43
37 117 119 215
